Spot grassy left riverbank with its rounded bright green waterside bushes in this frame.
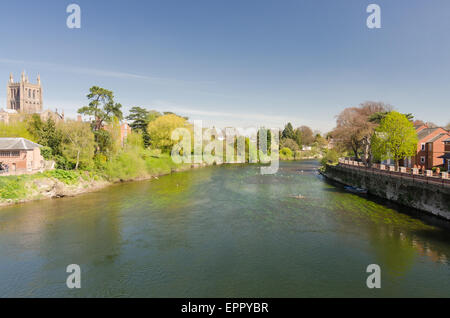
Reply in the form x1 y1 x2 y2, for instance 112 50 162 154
0 152 191 206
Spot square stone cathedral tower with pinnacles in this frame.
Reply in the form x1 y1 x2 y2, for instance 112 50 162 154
6 72 42 114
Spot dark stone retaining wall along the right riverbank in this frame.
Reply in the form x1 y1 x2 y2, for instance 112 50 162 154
324 165 450 220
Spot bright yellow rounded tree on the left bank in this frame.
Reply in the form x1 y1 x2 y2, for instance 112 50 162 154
147 114 188 151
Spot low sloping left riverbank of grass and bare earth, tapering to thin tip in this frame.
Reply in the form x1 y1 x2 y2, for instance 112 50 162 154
0 155 205 207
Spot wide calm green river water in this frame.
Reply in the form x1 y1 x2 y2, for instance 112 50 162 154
0 161 450 297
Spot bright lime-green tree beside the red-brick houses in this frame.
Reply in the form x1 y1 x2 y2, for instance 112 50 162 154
372 111 418 169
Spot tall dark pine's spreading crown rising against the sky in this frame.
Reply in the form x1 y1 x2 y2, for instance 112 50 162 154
78 86 123 131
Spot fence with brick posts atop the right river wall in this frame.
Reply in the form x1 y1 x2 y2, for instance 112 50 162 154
339 158 450 187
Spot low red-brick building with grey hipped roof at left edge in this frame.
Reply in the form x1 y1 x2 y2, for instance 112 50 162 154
0 138 44 173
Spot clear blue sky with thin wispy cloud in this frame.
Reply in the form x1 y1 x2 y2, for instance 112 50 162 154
0 0 450 132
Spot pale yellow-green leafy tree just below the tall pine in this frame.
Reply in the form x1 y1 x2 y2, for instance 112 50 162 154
60 121 95 170
